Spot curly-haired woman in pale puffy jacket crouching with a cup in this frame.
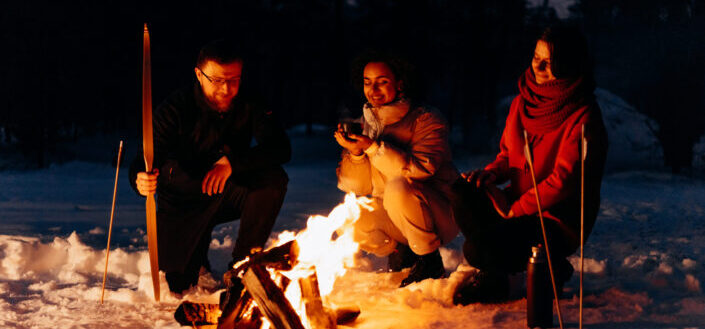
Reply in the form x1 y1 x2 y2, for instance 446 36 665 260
335 50 459 286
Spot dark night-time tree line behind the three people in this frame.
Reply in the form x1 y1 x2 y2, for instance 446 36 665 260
0 0 705 172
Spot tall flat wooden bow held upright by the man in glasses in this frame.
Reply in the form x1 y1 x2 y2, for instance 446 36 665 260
142 23 159 302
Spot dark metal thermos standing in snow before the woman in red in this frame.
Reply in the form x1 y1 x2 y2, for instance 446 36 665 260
526 244 553 328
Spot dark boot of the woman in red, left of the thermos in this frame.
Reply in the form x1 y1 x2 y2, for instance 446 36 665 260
453 271 509 305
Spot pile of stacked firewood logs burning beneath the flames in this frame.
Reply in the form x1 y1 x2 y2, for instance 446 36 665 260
174 240 360 329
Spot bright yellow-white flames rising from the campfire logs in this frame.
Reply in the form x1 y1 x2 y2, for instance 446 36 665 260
263 193 372 328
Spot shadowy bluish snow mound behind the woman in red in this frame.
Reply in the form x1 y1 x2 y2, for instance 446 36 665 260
491 88 664 171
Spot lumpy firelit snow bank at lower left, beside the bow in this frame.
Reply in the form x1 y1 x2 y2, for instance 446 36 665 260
0 232 218 328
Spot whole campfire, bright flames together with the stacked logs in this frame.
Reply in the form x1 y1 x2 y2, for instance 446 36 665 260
176 193 371 329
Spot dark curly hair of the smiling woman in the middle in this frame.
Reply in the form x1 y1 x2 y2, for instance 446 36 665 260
350 50 421 99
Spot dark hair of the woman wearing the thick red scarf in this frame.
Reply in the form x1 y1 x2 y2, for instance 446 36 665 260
538 26 593 79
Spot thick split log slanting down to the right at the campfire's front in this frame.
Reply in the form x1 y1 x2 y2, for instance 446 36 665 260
242 264 304 329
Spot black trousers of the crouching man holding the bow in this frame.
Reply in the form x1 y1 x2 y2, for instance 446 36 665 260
157 161 289 292
